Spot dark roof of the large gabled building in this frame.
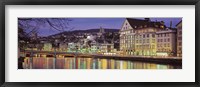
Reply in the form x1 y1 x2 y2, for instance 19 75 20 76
126 18 166 28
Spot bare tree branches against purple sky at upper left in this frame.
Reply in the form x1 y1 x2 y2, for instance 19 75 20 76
18 18 71 48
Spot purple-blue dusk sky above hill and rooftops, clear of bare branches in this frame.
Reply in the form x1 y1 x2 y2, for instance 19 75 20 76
36 18 182 36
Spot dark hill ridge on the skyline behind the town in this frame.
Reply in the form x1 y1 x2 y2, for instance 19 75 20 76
50 28 120 36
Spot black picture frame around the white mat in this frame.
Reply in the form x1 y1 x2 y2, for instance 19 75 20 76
0 0 200 87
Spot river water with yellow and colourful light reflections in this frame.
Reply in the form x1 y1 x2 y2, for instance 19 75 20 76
23 57 181 69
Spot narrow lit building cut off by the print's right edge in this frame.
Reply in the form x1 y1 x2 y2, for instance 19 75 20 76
176 21 182 57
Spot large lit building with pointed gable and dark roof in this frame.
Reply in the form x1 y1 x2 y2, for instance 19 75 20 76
120 18 166 55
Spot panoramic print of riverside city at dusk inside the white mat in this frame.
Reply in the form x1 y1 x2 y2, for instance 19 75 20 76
18 18 182 69
